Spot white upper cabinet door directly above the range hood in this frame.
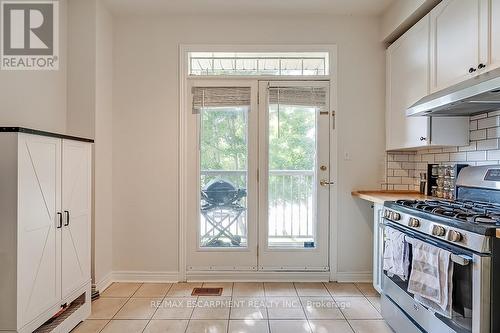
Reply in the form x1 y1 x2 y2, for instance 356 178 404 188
431 0 489 92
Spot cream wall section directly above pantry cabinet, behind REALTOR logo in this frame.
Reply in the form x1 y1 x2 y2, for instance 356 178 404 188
0 0 67 133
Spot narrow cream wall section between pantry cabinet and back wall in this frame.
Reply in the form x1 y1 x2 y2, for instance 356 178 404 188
66 0 113 288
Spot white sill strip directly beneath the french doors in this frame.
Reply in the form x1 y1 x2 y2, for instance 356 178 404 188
186 271 330 282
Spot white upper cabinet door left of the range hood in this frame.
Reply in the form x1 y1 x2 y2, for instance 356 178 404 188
386 16 429 150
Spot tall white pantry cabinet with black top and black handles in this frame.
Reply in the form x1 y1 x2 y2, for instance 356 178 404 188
0 128 92 332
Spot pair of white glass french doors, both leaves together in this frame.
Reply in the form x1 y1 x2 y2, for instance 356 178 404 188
185 79 330 271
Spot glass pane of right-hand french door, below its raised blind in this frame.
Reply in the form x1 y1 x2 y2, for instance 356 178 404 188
267 98 317 248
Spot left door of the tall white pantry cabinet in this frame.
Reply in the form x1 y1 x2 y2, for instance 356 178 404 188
17 134 61 327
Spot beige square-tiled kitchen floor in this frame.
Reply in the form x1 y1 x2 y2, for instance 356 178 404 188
73 282 392 333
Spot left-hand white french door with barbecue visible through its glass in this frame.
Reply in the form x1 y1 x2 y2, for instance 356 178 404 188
187 80 258 271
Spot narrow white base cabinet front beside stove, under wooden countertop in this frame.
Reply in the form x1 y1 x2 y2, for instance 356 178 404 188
373 204 384 293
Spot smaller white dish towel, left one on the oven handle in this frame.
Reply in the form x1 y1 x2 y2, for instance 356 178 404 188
384 227 409 281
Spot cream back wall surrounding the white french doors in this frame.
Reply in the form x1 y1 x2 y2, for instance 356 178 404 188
113 16 385 274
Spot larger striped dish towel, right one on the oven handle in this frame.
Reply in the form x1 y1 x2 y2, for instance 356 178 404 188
408 239 453 318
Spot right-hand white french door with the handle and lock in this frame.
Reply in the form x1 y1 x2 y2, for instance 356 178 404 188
258 81 330 271
